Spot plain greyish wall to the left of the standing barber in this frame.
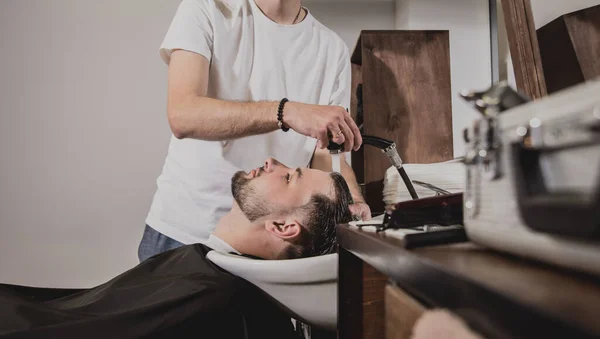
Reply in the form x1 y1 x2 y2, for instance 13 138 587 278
0 0 178 286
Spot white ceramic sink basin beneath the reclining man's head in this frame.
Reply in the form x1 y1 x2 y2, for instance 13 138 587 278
206 251 338 330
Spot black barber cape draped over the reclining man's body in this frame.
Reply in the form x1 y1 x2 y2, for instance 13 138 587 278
0 244 294 339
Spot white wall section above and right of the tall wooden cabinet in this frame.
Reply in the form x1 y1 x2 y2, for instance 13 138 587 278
396 0 491 157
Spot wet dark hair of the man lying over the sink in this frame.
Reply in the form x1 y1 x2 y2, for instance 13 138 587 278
283 173 353 259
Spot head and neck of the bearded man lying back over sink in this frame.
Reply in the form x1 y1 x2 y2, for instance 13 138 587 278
206 158 352 259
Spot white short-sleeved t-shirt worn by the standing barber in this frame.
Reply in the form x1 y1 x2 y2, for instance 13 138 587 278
146 0 351 244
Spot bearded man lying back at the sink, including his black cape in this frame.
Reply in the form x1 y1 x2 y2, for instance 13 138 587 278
0 159 352 338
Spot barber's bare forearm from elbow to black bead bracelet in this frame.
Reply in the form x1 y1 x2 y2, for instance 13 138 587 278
168 96 279 141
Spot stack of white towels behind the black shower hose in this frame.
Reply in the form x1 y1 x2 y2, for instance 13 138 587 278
383 160 466 205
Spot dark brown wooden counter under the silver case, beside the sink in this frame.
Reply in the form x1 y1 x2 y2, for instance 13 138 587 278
338 225 600 339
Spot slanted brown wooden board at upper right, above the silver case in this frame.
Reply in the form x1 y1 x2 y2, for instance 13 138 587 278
502 0 547 99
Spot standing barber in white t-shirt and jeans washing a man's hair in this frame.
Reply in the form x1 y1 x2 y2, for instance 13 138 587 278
138 0 371 260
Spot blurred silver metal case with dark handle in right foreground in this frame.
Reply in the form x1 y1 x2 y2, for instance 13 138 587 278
462 80 600 276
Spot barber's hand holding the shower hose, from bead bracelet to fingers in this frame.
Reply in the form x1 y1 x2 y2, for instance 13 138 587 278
283 102 362 152
